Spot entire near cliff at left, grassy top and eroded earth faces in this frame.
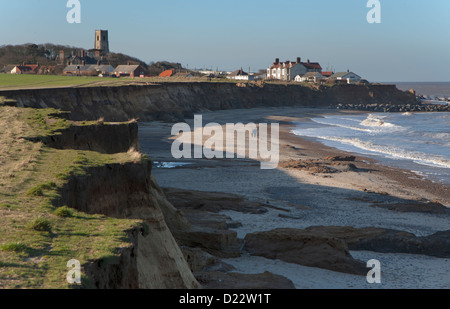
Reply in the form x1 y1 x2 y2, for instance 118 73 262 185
0 106 200 289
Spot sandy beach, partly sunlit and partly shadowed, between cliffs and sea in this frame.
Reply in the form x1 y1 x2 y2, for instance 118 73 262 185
139 107 450 289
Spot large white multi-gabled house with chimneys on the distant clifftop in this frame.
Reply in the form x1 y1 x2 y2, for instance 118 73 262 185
267 57 322 80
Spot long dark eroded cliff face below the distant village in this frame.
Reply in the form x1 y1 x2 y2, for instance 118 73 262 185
0 83 416 121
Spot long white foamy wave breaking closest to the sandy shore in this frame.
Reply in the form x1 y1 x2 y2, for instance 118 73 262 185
317 136 450 169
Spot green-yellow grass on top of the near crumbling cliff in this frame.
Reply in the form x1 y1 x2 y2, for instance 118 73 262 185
0 106 141 288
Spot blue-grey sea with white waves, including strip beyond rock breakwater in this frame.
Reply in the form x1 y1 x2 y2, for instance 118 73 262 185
292 83 450 185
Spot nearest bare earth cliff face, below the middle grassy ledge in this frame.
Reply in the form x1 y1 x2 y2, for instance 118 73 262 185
59 160 199 289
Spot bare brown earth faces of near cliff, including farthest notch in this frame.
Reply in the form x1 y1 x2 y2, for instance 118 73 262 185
28 113 200 289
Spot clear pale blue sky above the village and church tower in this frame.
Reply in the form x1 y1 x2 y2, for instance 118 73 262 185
0 0 450 82
